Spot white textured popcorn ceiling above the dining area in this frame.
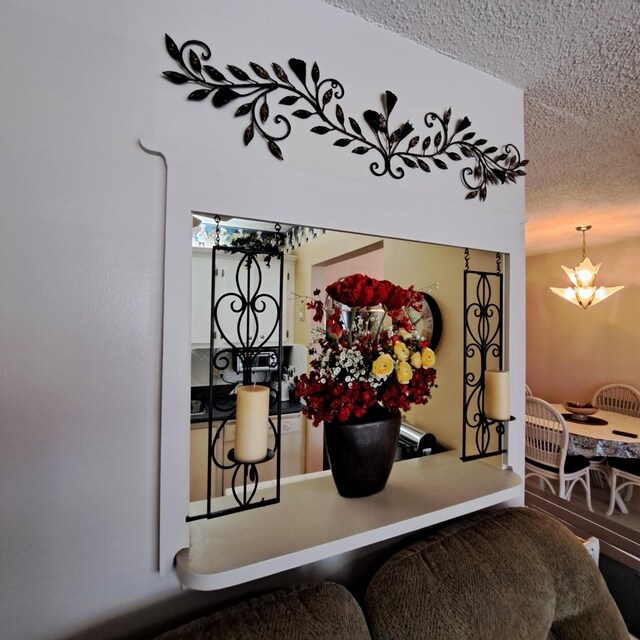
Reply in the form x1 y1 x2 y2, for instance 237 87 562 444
326 0 640 255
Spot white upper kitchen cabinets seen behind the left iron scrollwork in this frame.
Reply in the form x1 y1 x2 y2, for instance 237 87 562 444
191 247 296 349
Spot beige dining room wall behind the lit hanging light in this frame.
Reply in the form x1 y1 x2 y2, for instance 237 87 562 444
526 238 640 402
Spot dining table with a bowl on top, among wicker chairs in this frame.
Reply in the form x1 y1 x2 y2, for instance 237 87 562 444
553 404 640 458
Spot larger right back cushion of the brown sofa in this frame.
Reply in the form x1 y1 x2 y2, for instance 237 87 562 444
364 508 629 640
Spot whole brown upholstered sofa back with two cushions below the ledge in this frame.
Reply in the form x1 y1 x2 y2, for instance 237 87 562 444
160 508 629 640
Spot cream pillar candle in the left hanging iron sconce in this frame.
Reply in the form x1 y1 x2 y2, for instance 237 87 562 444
234 385 269 462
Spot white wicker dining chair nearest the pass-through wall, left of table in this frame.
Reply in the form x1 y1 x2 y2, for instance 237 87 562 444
524 397 593 511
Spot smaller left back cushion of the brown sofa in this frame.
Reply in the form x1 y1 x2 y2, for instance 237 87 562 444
157 582 370 640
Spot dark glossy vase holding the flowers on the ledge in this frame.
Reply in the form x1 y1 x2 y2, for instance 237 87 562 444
324 410 400 498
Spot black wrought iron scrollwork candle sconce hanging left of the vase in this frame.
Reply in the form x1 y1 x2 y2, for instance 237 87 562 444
187 218 284 521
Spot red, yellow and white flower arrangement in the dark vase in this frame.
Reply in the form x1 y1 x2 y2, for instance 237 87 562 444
295 273 436 426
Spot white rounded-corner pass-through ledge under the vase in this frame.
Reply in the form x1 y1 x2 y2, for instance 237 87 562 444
176 451 523 591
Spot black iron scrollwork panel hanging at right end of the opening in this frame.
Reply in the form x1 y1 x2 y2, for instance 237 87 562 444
462 250 506 461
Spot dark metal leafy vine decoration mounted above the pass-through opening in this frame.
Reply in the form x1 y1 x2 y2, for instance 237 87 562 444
163 35 528 200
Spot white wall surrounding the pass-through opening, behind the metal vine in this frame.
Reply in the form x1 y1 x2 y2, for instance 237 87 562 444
0 0 524 640
